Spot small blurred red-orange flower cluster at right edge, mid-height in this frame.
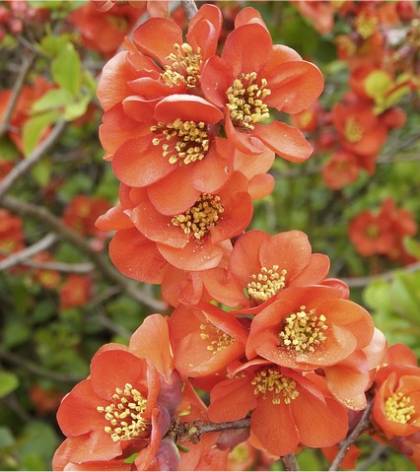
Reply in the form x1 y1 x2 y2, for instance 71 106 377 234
349 198 417 263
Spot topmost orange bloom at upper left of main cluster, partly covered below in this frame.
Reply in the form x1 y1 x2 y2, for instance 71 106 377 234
98 2 222 111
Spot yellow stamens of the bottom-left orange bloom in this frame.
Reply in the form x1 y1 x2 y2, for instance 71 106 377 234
96 383 148 442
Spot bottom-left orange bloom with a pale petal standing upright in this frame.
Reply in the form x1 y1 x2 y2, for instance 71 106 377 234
53 315 181 470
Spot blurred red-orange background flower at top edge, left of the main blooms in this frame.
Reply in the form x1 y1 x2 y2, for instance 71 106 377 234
69 0 142 56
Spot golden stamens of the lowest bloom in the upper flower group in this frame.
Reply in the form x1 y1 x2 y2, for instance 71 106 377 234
171 193 225 239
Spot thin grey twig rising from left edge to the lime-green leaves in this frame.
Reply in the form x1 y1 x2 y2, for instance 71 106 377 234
0 121 66 201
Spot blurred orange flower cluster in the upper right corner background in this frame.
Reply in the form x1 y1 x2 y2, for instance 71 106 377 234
293 1 419 190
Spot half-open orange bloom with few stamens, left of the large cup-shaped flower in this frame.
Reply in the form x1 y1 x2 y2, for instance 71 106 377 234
169 305 248 377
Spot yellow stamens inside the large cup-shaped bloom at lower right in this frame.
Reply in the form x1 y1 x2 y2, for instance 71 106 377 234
279 305 328 352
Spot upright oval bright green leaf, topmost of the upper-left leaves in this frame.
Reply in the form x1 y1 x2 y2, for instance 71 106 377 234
51 43 82 95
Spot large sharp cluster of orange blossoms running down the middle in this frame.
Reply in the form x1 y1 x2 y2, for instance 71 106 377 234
53 5 420 470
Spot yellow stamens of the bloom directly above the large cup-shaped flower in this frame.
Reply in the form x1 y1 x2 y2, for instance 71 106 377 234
246 265 287 303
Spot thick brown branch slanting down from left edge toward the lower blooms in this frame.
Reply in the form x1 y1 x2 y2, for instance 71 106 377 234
2 196 166 311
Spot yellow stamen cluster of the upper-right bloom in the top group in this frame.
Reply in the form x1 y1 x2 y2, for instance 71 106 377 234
226 72 271 129
